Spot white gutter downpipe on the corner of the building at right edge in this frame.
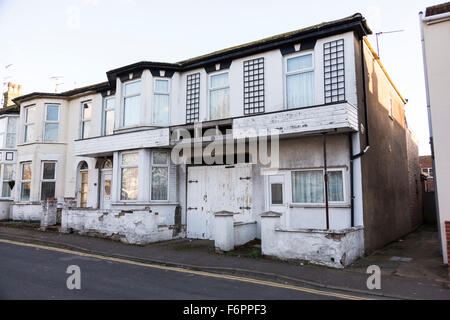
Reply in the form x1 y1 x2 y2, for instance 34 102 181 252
419 11 442 255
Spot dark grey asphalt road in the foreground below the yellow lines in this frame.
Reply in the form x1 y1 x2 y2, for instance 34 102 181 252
0 243 360 300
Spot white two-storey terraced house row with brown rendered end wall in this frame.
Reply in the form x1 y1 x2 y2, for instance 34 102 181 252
7 14 421 267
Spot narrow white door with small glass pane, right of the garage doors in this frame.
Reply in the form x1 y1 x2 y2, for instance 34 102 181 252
266 174 289 225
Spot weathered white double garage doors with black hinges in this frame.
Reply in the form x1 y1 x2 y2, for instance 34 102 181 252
187 164 252 239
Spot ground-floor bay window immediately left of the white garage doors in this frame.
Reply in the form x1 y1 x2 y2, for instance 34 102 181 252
151 151 169 200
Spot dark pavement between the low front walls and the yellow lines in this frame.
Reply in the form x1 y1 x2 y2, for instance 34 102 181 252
0 223 450 300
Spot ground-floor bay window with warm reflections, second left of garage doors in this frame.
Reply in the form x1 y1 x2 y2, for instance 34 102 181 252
120 152 139 200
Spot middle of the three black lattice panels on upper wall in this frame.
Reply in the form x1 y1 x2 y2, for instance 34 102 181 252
244 58 264 114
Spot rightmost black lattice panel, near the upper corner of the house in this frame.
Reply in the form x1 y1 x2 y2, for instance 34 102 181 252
323 39 345 103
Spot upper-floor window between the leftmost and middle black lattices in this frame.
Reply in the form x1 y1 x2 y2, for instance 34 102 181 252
209 72 230 120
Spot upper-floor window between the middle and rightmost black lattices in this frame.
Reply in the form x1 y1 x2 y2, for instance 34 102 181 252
286 53 314 109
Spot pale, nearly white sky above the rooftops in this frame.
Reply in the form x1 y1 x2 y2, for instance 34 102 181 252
0 0 445 154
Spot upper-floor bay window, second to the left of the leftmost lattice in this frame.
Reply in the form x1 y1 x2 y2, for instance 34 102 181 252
122 80 141 126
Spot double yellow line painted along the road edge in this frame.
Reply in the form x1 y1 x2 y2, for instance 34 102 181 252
0 239 370 300
